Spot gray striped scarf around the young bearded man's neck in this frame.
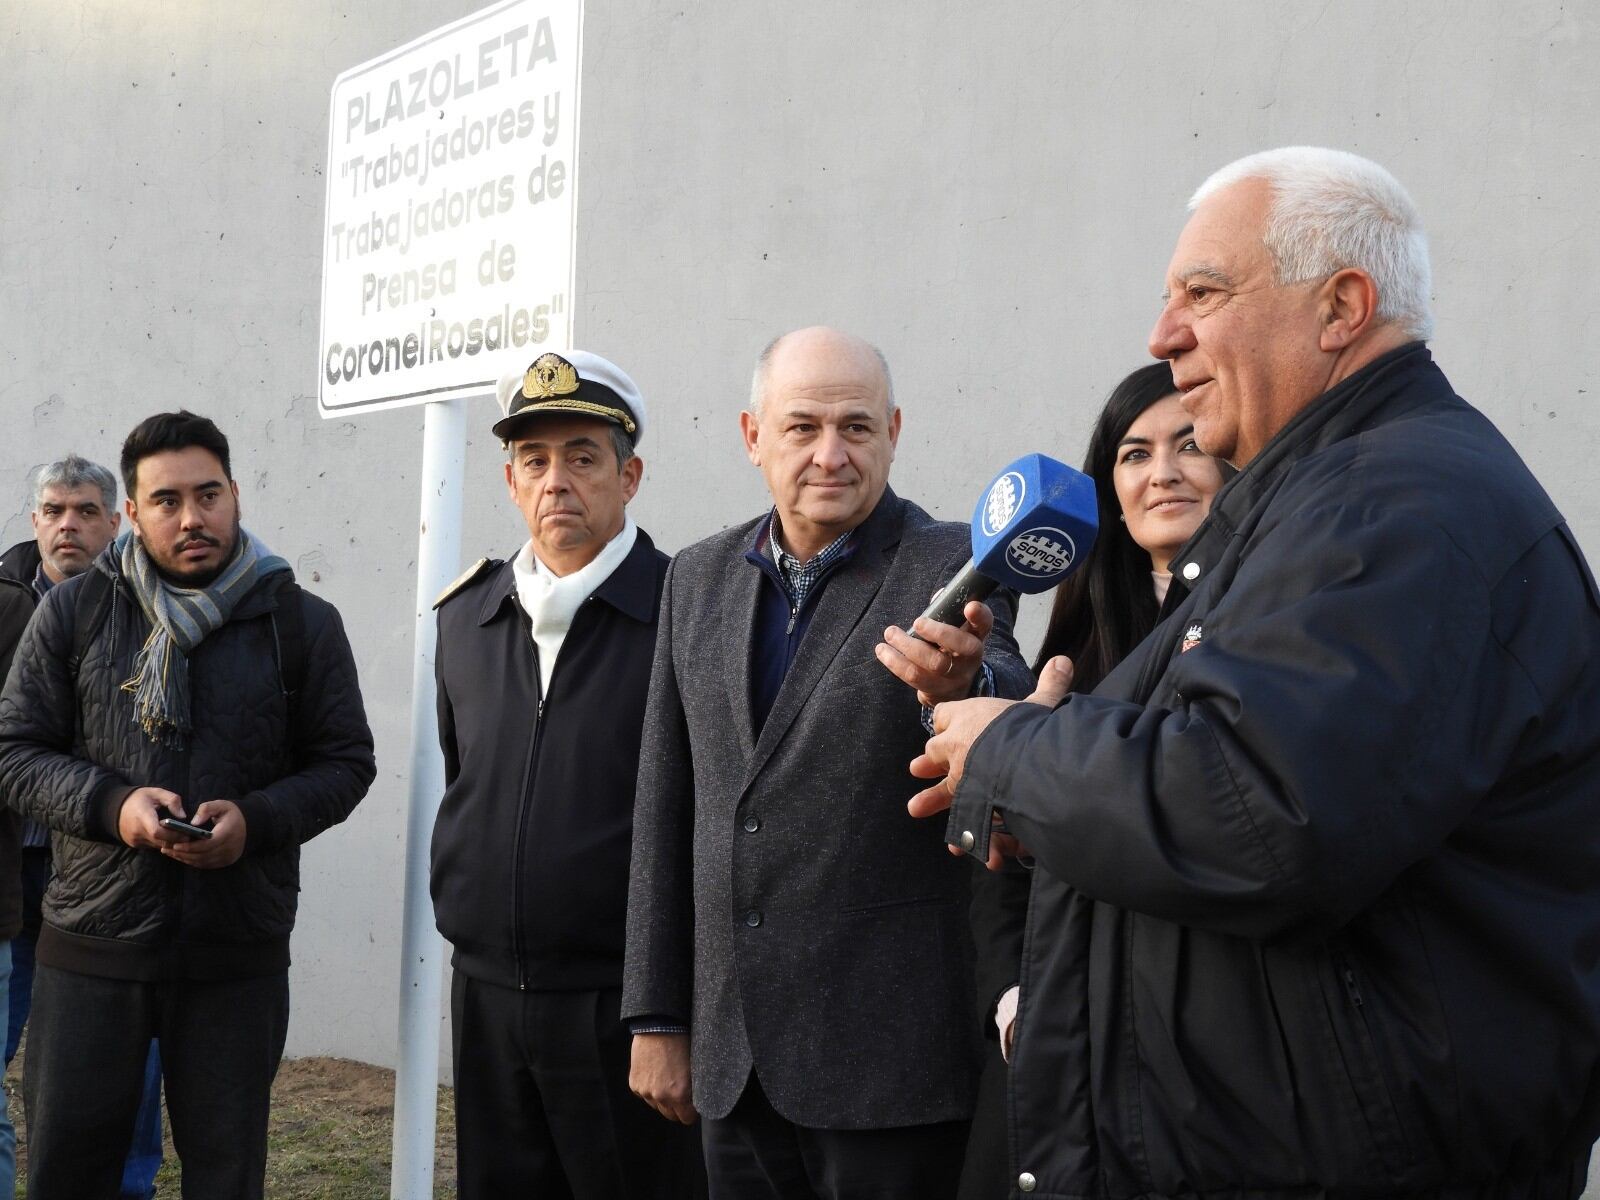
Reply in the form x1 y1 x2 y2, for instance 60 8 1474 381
117 530 290 749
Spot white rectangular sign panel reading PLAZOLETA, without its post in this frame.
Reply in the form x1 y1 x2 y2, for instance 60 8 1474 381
317 0 582 416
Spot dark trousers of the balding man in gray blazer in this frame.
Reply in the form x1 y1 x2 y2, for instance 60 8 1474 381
701 1074 972 1200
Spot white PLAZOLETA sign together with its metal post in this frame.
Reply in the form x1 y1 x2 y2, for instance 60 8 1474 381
317 0 582 1200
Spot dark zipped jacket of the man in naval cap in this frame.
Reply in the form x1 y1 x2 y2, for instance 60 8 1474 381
430 530 667 990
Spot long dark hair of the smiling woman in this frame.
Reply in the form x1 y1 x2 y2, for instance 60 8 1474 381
1034 362 1203 691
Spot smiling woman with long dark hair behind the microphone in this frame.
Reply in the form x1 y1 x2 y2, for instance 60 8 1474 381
960 362 1234 1200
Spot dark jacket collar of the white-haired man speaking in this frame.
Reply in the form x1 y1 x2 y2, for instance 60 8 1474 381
1162 342 1450 595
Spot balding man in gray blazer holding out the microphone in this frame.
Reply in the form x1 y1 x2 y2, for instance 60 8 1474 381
622 328 1030 1200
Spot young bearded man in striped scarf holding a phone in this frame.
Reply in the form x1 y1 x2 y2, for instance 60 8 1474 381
0 411 374 1200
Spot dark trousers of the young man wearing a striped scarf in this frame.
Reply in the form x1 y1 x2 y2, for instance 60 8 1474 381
22 965 290 1200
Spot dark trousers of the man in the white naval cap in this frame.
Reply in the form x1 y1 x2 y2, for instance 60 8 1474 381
450 971 706 1200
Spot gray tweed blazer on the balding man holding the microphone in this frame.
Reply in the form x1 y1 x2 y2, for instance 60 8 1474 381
622 490 1032 1130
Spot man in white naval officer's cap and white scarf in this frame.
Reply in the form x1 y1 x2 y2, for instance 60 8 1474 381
432 350 699 1200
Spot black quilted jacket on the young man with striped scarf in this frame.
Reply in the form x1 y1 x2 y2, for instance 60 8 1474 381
0 550 376 979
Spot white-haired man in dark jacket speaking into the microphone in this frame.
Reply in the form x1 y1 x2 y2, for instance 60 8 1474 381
912 147 1600 1200
